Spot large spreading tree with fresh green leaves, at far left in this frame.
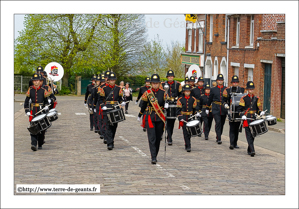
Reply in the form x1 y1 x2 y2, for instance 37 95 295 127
15 14 105 86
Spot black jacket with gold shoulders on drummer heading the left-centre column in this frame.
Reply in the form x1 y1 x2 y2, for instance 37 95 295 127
98 85 123 115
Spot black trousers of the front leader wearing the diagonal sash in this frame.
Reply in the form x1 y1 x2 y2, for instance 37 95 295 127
145 121 164 159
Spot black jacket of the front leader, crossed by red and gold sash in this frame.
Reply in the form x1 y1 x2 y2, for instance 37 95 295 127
138 88 167 122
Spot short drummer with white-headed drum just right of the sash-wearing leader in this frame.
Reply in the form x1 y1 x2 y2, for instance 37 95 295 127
177 84 200 152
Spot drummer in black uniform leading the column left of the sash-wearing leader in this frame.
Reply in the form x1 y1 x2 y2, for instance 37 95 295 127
99 72 126 150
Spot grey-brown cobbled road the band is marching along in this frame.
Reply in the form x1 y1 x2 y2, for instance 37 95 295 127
14 97 285 195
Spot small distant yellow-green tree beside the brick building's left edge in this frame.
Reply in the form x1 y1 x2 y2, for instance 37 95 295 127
166 41 185 78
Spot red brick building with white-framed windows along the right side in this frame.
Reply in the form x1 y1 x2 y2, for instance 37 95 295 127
181 14 285 118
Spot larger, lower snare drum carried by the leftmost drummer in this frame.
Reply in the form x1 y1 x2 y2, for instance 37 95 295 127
27 114 52 135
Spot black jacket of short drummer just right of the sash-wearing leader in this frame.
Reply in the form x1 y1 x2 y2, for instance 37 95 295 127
177 96 198 121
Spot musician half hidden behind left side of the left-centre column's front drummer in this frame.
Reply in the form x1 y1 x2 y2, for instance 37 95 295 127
97 73 108 144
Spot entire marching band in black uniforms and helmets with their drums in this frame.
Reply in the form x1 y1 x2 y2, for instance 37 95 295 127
24 66 276 164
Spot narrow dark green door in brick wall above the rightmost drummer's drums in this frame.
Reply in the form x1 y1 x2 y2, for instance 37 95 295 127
263 64 272 113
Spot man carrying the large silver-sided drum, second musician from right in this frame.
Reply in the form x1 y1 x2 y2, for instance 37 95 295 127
223 75 244 149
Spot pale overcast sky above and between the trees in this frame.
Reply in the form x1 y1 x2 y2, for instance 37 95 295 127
14 14 185 47
